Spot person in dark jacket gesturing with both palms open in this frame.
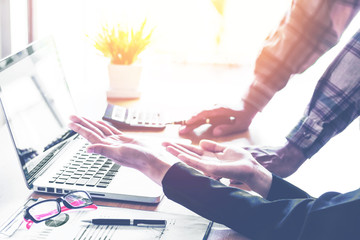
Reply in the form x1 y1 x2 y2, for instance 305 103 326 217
69 116 360 240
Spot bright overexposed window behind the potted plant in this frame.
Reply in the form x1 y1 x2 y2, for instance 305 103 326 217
34 0 290 64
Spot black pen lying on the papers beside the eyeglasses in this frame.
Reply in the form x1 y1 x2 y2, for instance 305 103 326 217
83 218 166 227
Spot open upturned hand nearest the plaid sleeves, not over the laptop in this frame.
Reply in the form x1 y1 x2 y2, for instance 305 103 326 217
163 140 272 196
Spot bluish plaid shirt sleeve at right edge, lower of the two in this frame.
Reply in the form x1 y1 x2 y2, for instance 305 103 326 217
287 30 360 158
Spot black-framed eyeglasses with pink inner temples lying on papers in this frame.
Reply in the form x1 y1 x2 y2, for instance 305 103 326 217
24 191 97 229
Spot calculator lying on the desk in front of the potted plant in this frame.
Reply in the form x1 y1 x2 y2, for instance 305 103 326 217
103 103 166 131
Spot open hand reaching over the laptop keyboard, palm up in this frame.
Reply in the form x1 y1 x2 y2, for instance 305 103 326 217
69 116 171 184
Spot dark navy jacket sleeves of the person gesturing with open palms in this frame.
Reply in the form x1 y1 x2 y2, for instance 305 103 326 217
162 163 360 240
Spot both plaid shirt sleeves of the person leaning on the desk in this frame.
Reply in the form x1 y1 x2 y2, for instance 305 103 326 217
243 0 360 158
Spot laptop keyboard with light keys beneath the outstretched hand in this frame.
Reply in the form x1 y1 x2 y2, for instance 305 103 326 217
49 144 120 188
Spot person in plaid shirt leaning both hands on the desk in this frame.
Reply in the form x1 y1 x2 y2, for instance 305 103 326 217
179 0 360 177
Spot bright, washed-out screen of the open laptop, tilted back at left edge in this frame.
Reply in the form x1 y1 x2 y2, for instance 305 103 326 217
0 38 74 185
